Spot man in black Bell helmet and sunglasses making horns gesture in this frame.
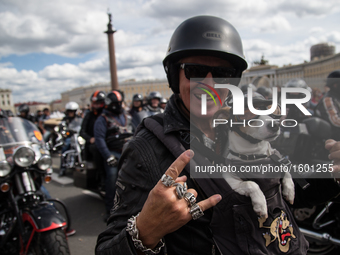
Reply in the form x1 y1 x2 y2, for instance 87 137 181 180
96 16 340 255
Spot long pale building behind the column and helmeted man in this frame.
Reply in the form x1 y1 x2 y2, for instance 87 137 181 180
59 43 340 108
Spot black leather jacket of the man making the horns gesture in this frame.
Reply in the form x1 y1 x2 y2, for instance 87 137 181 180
96 94 217 255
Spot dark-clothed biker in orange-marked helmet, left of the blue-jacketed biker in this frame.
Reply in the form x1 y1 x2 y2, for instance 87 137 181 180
79 90 106 181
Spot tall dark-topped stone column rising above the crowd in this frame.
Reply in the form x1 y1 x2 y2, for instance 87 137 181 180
104 13 118 90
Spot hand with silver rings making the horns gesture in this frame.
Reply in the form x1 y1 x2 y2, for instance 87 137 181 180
136 150 222 249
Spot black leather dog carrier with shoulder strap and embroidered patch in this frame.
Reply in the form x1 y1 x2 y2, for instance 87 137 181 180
144 114 308 255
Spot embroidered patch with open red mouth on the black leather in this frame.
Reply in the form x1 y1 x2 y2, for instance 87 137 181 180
258 210 296 252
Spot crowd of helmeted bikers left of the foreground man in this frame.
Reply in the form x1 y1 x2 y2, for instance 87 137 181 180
18 90 167 220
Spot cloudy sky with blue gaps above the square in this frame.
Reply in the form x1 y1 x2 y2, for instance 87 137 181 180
0 0 340 102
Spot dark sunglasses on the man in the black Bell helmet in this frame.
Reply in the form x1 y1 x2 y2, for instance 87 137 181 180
180 63 236 84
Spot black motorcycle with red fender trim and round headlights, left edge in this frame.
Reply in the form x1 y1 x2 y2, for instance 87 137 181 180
0 117 70 255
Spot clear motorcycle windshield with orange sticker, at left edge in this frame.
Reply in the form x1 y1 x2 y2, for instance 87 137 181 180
0 117 44 147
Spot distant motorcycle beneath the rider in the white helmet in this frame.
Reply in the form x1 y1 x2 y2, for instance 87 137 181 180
53 118 86 173
